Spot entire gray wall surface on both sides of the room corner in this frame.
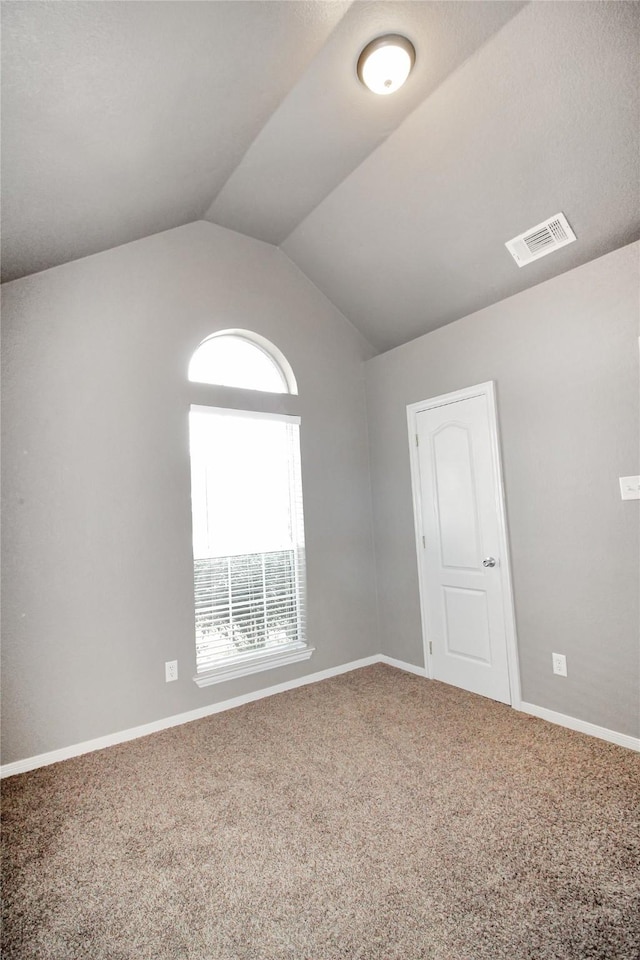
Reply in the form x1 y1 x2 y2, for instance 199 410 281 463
2 223 640 763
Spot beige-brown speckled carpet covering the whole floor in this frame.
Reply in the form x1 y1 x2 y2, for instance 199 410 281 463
3 666 640 960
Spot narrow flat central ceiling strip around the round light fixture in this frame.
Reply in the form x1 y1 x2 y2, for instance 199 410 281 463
206 0 523 244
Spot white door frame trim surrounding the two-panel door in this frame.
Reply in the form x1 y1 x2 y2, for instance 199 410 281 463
407 380 522 710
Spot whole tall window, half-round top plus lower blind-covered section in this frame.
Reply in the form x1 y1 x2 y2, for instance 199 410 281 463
189 331 313 686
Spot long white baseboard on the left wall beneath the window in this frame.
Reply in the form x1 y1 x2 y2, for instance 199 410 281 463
0 654 380 778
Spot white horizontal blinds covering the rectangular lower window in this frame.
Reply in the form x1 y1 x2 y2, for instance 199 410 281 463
190 407 305 674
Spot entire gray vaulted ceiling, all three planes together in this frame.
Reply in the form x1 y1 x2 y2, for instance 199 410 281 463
2 0 640 350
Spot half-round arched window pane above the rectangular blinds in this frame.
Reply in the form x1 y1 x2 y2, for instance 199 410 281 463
189 330 298 393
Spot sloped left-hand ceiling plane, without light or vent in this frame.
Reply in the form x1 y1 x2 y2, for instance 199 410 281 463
2 0 349 279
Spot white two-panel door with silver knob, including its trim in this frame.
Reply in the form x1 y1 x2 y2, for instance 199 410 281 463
410 384 515 703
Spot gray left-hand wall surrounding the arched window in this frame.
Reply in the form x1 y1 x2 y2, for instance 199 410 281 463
2 222 379 763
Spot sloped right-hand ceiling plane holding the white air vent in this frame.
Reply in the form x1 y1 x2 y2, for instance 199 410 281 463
283 2 640 350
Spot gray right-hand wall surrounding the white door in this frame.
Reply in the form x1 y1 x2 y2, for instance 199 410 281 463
366 243 640 736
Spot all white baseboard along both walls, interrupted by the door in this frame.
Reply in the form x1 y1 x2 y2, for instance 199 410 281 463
0 653 640 778
